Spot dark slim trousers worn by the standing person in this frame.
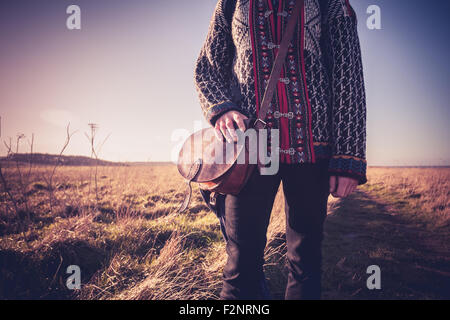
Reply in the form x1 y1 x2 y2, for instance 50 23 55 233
220 160 329 299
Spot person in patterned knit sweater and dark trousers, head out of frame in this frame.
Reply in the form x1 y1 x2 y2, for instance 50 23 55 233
195 0 367 299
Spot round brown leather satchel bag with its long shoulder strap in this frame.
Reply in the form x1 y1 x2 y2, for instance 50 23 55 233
177 0 304 212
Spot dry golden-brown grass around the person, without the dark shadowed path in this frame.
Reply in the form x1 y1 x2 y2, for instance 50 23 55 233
0 165 450 299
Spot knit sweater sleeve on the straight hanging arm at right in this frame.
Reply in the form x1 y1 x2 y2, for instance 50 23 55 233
324 0 367 185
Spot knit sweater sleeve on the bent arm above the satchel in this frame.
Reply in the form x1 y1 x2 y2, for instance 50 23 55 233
194 0 240 126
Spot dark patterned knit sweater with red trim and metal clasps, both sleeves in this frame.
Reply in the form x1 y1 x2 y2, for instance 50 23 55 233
195 0 367 184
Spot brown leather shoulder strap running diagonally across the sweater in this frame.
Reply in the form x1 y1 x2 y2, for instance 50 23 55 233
254 0 304 129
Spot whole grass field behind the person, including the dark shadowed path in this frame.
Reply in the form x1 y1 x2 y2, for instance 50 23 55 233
0 165 450 299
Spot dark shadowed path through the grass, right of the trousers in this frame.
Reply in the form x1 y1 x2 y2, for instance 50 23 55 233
271 190 450 299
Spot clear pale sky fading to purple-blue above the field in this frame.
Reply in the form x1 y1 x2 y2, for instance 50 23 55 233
0 0 450 166
